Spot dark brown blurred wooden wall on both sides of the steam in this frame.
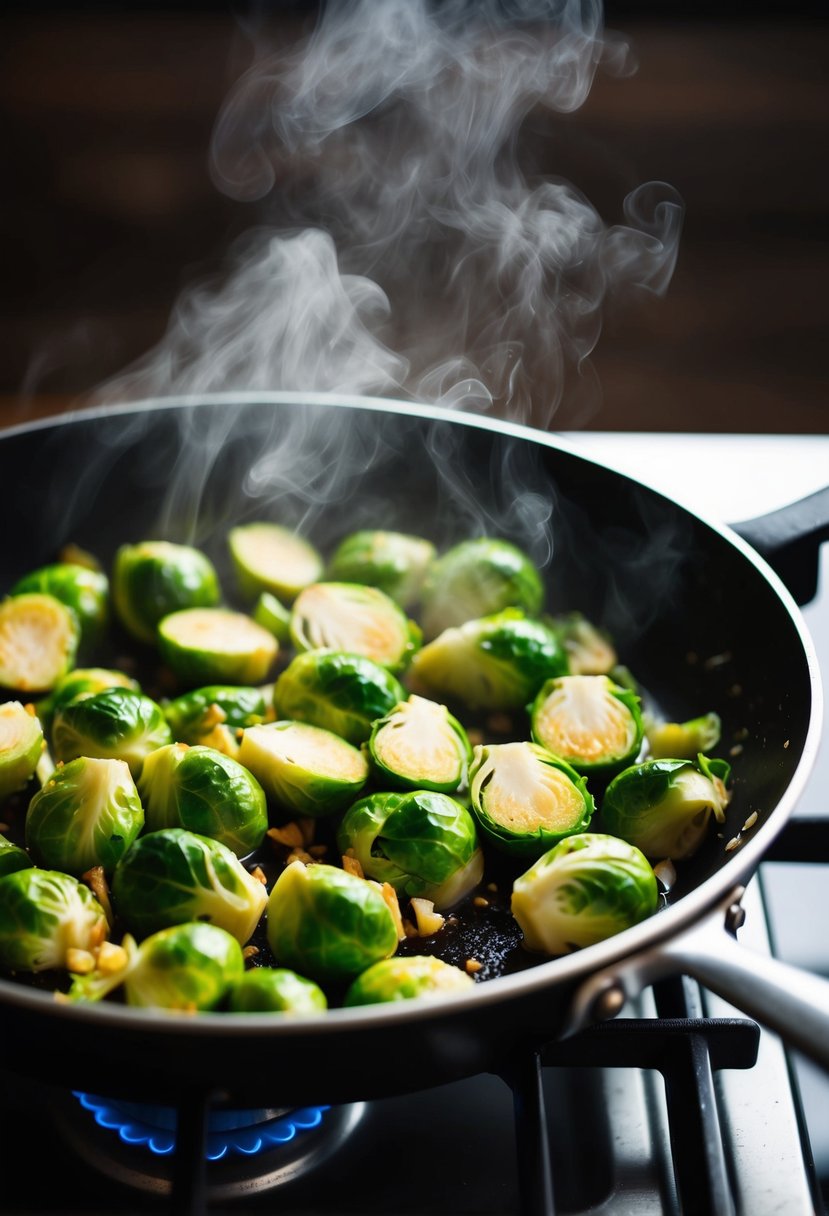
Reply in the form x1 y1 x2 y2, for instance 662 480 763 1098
0 2 829 434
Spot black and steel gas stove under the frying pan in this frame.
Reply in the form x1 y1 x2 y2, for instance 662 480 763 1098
0 432 829 1216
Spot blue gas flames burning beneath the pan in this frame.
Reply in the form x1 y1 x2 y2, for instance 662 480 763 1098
73 1091 331 1161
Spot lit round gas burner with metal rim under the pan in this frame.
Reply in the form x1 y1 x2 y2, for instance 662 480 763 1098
53 1093 366 1201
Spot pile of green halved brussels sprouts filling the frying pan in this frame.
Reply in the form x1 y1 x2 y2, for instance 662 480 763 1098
0 520 729 1015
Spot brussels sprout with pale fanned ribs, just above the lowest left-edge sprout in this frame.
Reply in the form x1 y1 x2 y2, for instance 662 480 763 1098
26 756 143 878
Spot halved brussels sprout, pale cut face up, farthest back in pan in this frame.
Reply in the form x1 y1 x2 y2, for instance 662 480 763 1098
227 520 325 603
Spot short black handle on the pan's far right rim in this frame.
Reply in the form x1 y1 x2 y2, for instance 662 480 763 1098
731 486 829 604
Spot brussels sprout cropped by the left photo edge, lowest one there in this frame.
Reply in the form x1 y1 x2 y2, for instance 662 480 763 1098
0 867 108 972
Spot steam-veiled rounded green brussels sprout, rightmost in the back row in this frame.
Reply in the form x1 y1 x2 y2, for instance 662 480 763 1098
419 536 545 638
